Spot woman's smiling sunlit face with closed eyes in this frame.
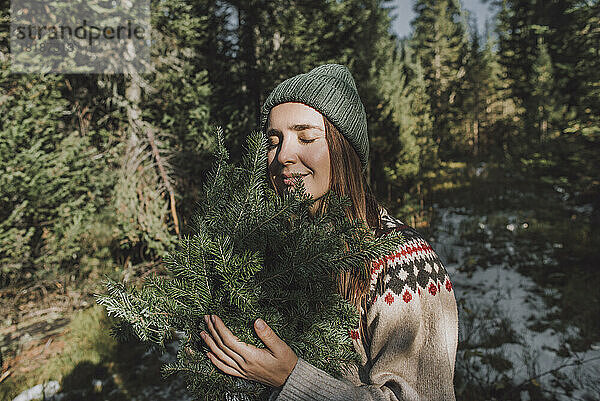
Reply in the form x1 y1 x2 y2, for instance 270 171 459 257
267 103 331 199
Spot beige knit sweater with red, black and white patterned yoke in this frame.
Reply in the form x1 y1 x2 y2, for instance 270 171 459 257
269 208 458 401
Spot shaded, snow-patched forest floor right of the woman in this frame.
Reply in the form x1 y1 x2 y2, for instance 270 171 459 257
429 160 600 400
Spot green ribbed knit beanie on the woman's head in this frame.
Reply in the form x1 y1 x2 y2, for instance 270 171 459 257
261 64 369 170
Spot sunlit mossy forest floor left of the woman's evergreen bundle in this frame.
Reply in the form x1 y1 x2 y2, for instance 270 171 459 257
0 268 189 401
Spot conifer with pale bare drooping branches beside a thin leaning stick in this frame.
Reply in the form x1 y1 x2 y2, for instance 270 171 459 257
99 0 212 261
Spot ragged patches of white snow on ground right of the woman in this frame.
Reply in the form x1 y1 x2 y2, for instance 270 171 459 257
432 207 600 400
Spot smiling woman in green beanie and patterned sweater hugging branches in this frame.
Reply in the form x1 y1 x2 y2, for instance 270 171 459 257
202 64 458 401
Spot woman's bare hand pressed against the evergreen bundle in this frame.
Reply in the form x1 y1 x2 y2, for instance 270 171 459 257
200 315 298 387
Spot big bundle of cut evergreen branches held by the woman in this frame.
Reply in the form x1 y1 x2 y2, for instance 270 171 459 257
97 129 402 400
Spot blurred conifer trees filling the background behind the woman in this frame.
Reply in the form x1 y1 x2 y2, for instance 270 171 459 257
0 0 600 398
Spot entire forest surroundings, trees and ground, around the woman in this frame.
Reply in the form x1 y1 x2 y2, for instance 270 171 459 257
0 0 600 401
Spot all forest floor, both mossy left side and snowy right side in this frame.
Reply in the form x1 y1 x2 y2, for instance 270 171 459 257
0 160 600 401
